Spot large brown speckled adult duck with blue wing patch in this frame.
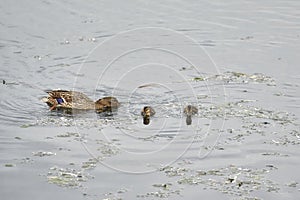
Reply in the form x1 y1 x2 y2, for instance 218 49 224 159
42 90 120 112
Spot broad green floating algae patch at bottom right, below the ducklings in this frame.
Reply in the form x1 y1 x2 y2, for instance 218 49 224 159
160 165 279 199
